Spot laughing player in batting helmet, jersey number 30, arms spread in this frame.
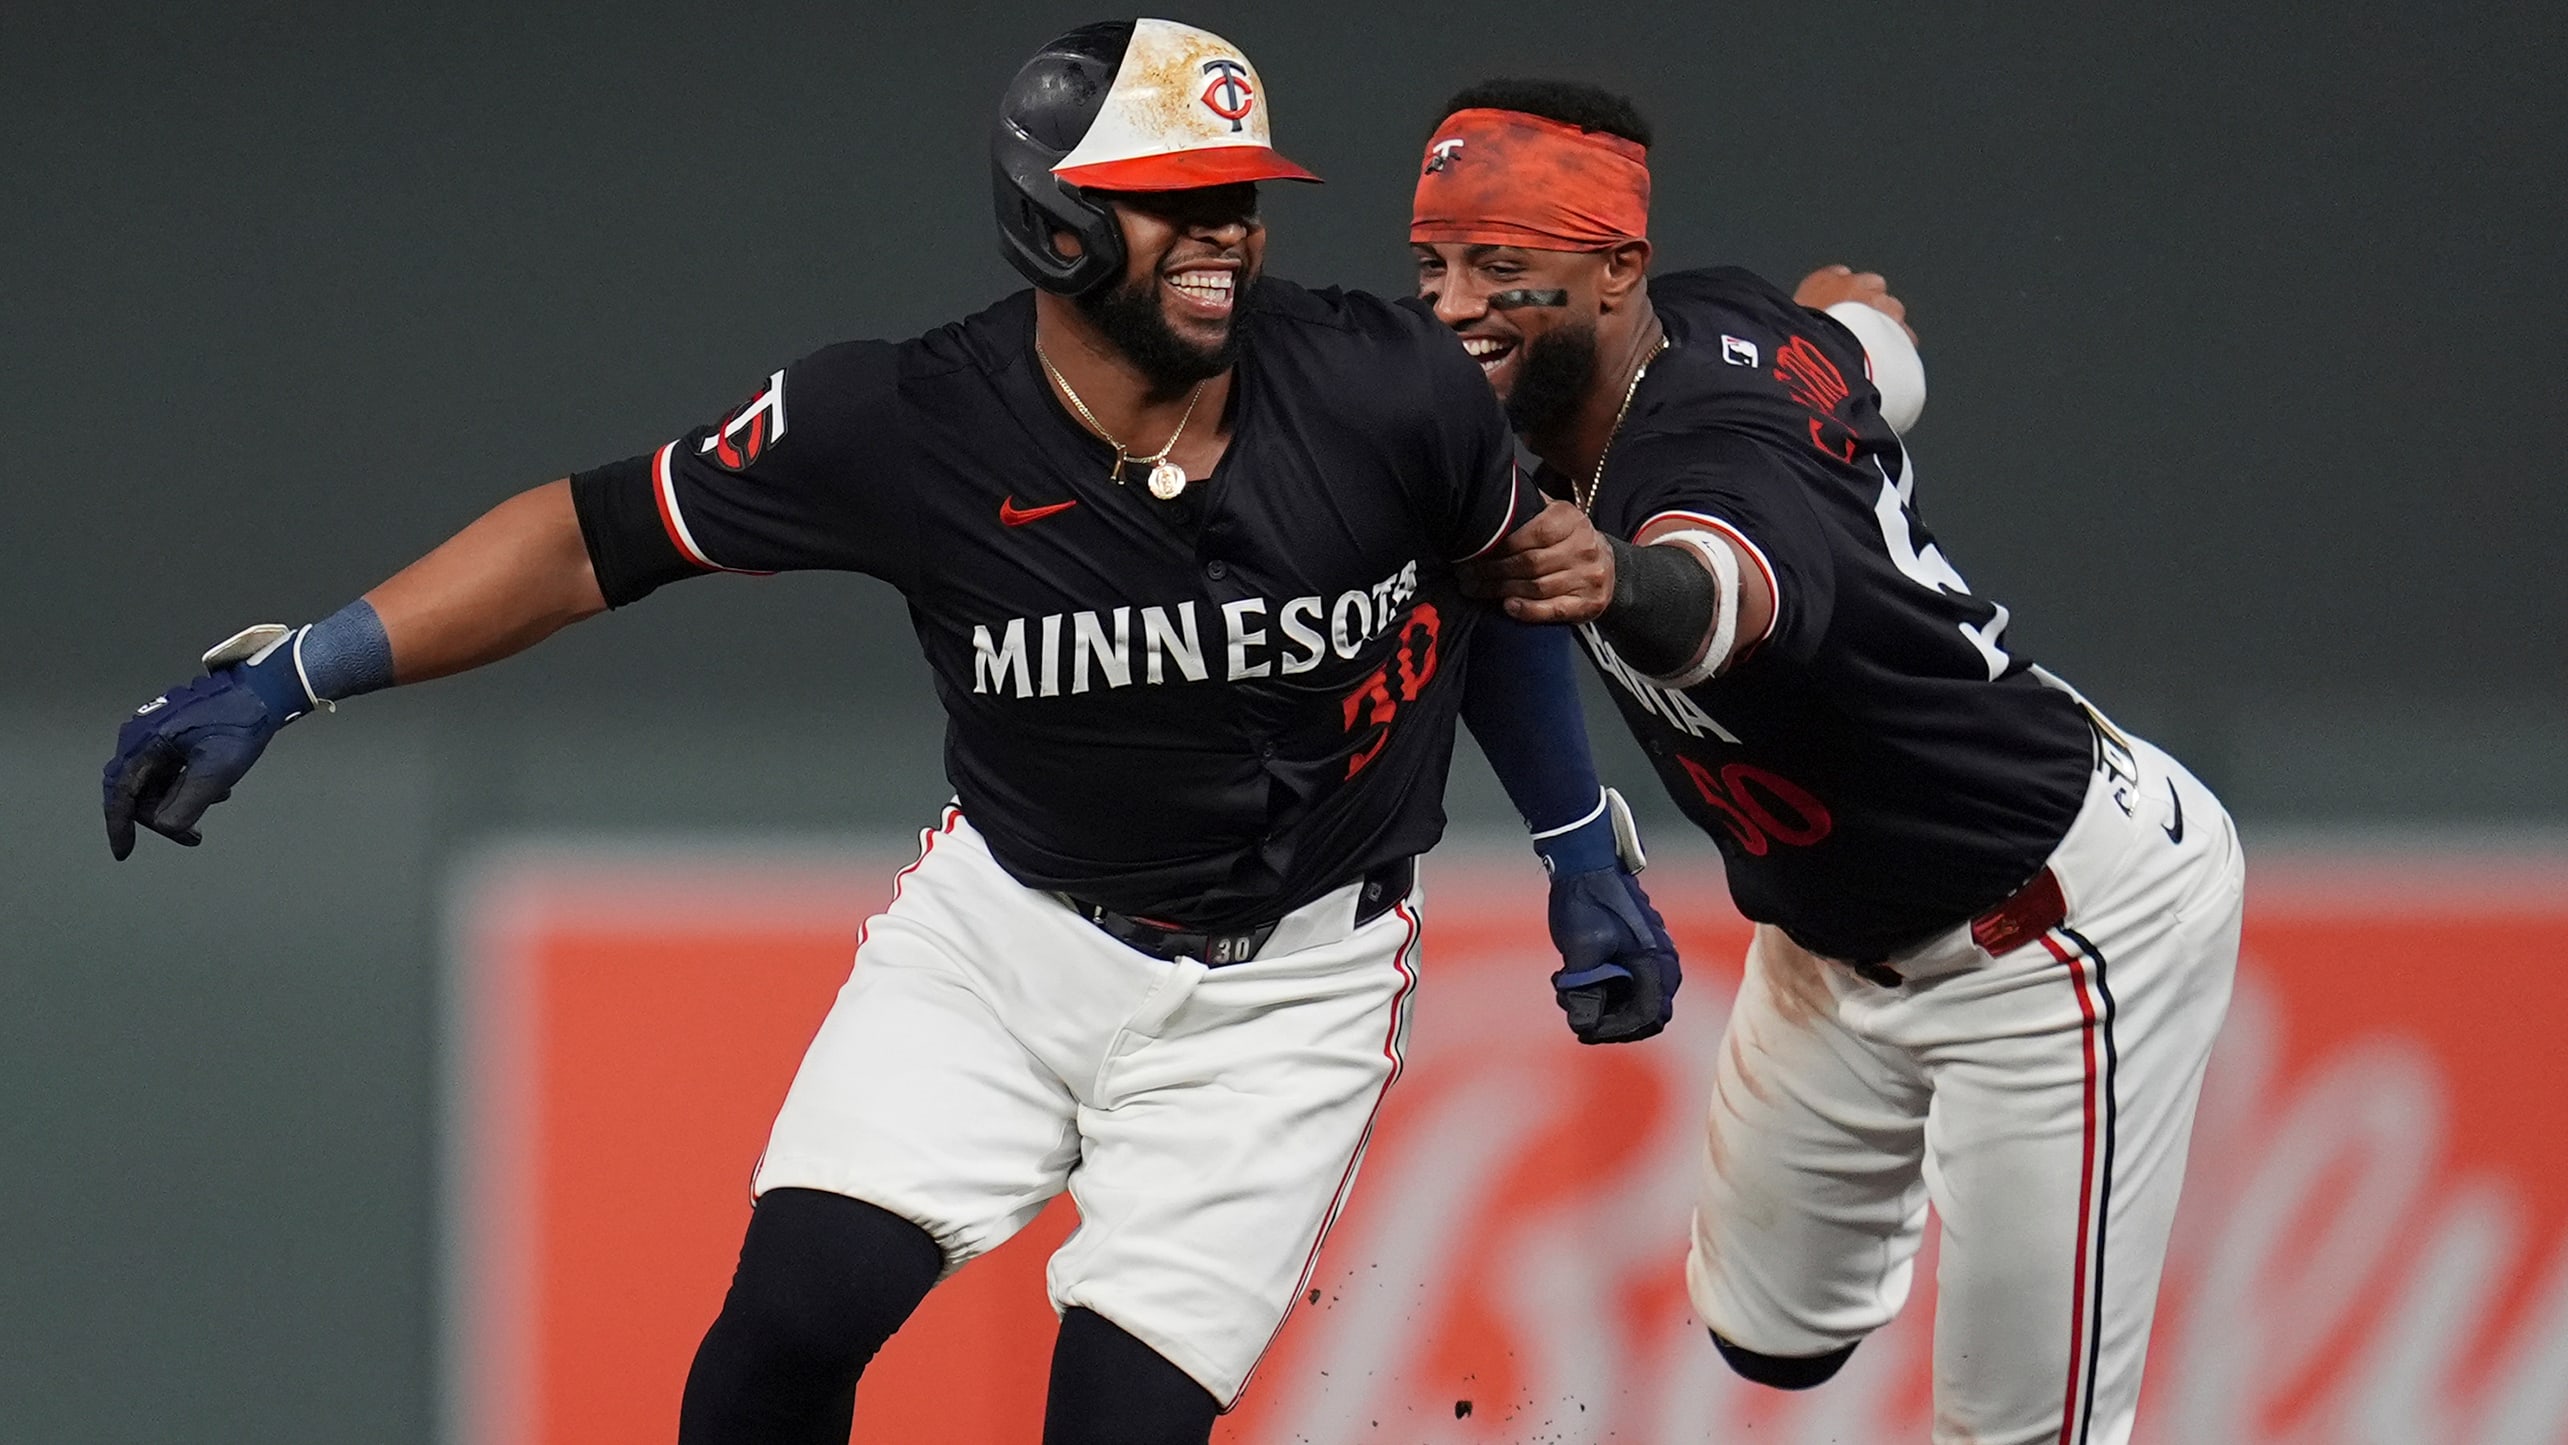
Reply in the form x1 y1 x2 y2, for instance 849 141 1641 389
105 21 1677 1445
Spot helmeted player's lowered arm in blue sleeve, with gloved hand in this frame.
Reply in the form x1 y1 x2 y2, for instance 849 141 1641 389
1461 616 1685 1045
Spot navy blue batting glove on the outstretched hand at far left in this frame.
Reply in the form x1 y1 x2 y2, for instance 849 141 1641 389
103 624 313 862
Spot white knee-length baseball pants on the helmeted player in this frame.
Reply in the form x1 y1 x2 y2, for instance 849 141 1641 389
755 808 1420 1409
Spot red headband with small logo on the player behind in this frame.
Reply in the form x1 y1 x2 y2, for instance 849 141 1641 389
1410 110 1649 252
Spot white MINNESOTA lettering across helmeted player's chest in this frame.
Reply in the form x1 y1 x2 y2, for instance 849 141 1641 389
971 562 1418 698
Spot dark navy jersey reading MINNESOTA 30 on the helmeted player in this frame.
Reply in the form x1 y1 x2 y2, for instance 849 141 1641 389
573 280 1541 929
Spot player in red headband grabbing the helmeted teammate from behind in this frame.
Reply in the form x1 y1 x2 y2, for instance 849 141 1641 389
1410 82 2242 1445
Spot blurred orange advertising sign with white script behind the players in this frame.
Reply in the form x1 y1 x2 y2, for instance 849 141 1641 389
447 852 2568 1445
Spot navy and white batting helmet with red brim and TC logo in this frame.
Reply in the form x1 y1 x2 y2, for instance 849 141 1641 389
989 21 1320 295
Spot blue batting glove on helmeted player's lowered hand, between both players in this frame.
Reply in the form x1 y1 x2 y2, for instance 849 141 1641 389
1533 788 1685 1045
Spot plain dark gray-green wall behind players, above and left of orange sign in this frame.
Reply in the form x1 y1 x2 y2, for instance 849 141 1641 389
0 0 2568 1445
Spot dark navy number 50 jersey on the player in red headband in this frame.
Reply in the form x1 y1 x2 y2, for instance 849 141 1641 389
1582 267 2095 960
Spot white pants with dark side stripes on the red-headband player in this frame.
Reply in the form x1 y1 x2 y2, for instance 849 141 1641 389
1687 742 2244 1445
